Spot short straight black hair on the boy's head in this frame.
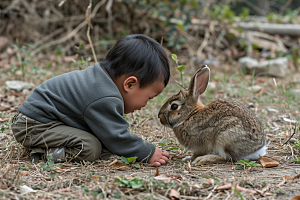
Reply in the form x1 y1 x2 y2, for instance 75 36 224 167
100 34 170 88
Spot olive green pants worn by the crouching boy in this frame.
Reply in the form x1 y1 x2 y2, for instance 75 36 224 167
11 112 102 161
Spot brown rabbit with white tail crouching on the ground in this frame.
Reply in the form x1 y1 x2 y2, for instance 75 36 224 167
158 65 267 165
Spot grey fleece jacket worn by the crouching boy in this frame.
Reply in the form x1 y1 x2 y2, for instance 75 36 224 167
19 63 155 162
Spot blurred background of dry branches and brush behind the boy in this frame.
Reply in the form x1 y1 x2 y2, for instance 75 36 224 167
0 0 300 83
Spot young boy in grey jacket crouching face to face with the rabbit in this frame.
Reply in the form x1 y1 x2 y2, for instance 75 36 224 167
11 34 170 166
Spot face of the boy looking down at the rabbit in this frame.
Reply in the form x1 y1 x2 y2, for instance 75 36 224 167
123 81 165 114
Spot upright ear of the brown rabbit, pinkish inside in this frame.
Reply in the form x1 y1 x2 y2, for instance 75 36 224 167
189 65 210 97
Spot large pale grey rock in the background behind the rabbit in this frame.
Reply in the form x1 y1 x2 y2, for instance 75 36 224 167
239 57 288 78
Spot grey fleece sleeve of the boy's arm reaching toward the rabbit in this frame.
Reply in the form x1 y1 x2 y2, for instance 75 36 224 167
84 97 155 163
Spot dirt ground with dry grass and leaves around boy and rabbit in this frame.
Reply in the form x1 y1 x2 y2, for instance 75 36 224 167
0 58 300 199
